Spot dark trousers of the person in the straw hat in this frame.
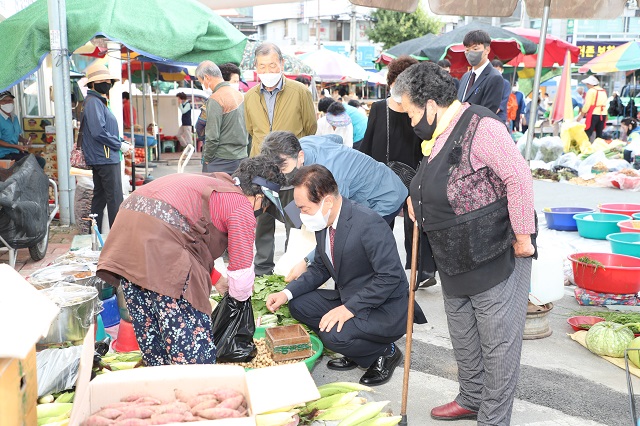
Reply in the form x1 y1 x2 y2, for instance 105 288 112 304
91 163 123 232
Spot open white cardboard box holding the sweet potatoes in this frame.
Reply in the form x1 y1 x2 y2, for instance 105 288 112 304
69 362 320 426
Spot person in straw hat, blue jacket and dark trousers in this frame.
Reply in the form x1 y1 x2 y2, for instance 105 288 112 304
80 65 132 232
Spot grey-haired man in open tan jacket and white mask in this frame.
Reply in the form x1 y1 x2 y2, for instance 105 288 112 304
244 42 317 275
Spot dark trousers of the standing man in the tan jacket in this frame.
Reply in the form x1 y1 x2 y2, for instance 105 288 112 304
253 188 293 275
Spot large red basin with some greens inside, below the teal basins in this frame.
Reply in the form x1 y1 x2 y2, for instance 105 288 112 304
569 253 640 294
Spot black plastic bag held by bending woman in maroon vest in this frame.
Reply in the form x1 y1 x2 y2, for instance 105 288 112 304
211 293 258 362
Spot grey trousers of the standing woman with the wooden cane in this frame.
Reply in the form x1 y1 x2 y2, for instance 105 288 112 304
443 258 532 426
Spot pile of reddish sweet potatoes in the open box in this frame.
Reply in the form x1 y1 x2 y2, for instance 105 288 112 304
82 388 247 426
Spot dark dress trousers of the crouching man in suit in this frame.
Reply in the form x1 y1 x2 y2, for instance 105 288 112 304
289 290 402 368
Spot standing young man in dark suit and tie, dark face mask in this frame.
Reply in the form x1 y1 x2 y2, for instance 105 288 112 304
458 30 504 113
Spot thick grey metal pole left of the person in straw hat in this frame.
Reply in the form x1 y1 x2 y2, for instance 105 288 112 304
47 0 71 225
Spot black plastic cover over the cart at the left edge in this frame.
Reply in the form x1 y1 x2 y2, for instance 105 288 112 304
0 155 49 248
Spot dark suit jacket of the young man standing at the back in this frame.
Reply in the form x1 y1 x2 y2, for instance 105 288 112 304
458 63 504 114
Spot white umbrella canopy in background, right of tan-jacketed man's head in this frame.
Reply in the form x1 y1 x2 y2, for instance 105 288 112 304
298 49 369 81
